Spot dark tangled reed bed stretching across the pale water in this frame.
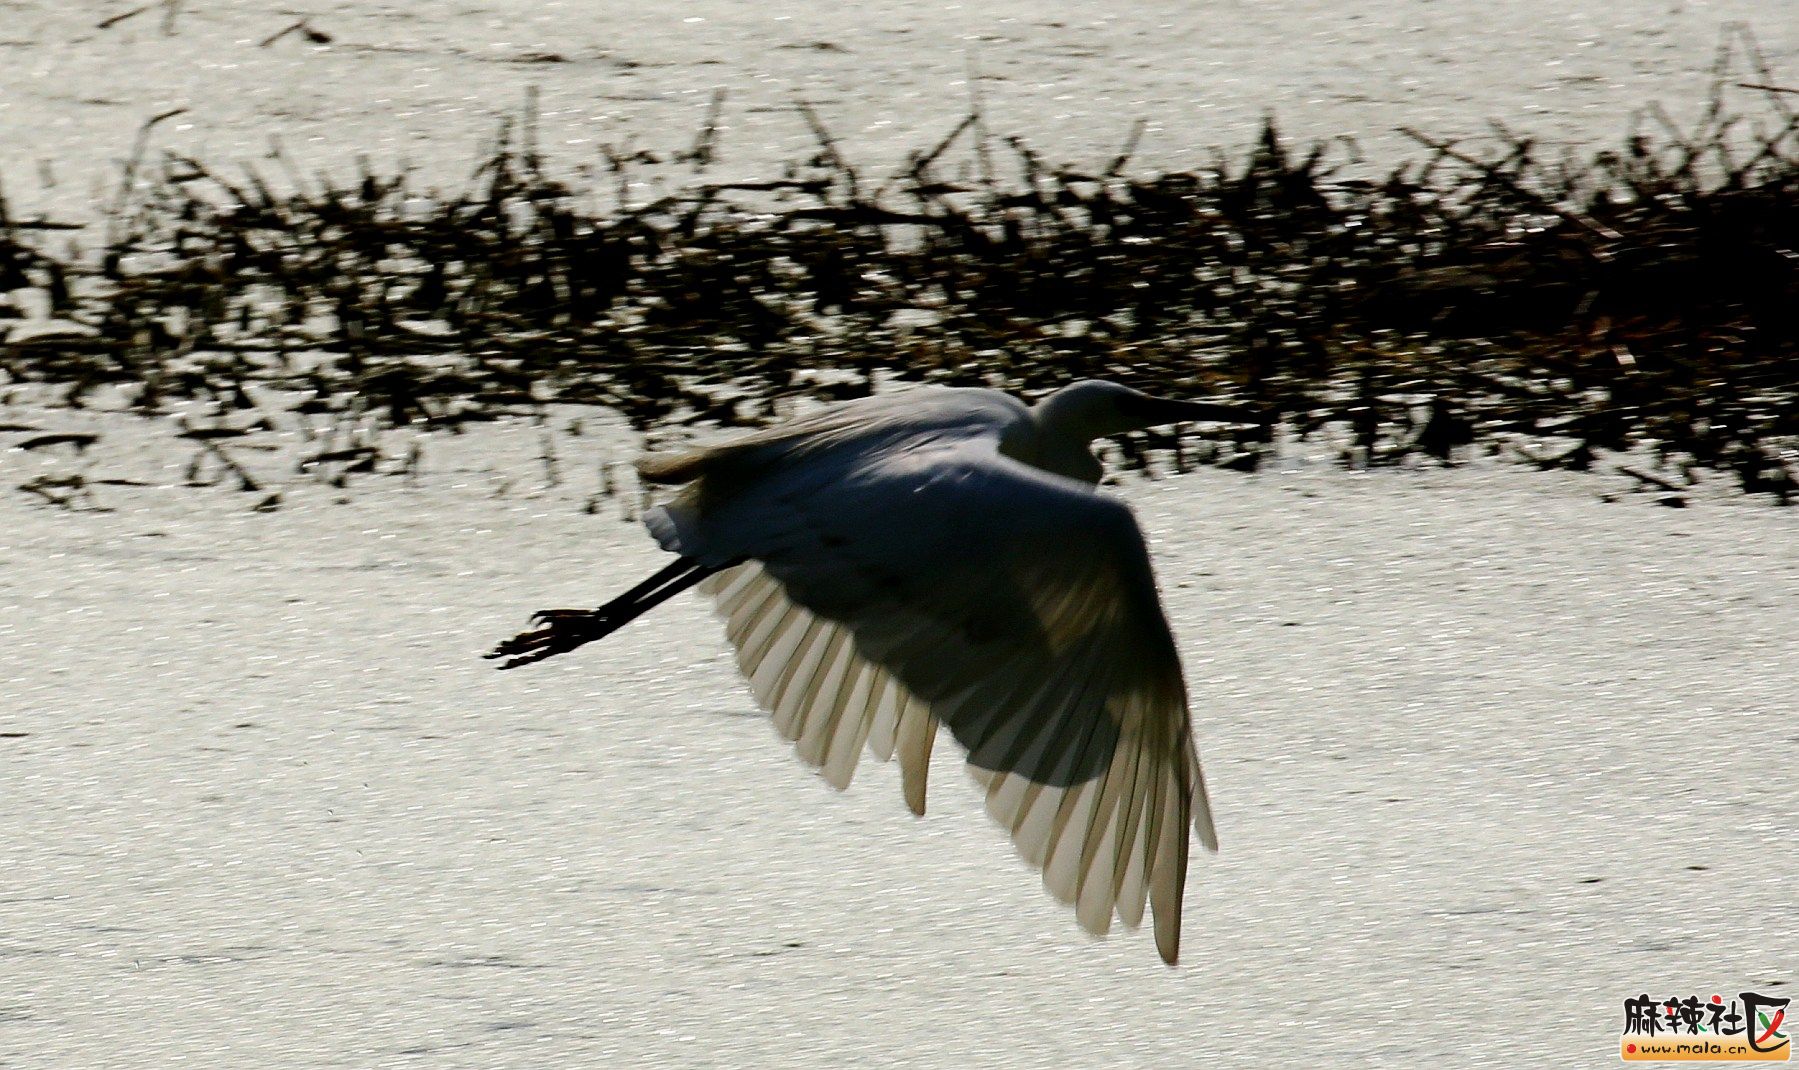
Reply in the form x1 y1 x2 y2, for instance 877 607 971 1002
0 67 1799 504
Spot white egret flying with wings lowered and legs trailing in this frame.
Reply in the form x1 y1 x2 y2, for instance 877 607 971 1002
488 381 1243 964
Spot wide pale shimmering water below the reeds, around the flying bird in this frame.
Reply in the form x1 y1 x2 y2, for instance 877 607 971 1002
0 408 1799 1066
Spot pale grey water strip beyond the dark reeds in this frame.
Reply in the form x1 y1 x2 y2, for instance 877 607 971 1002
0 0 1799 212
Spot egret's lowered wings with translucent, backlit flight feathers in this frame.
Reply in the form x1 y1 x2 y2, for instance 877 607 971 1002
653 444 1216 962
